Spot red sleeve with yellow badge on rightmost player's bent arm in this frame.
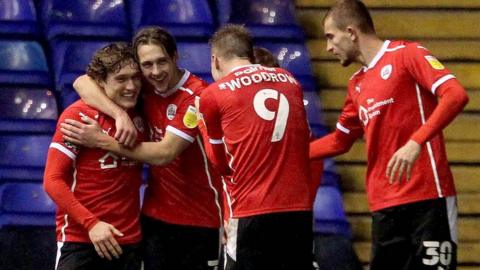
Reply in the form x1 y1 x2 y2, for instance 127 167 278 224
404 43 468 144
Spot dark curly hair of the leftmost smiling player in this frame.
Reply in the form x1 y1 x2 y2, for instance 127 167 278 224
87 42 137 81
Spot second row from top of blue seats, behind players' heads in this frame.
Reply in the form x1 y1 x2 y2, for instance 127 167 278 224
0 40 322 105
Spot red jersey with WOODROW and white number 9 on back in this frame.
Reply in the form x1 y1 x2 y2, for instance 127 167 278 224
200 65 313 218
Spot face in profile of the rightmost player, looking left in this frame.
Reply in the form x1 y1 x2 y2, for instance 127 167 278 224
324 16 359 67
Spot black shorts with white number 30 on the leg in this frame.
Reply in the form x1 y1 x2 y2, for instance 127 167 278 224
370 197 457 270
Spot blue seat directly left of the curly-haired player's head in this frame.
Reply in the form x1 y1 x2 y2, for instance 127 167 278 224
52 41 108 109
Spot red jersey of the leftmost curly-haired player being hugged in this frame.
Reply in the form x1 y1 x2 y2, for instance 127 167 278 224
44 100 143 244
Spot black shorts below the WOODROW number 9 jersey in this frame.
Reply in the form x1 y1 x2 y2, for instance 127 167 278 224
225 211 313 270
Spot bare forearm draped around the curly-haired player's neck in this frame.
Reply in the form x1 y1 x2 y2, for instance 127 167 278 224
73 74 137 147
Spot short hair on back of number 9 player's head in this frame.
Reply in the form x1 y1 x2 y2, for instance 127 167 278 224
209 24 254 62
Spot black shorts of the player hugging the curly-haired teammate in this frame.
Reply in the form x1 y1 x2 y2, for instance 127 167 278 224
141 216 220 270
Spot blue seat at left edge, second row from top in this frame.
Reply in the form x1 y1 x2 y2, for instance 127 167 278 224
0 40 50 87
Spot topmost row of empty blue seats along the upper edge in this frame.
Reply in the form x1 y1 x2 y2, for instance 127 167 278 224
0 0 304 40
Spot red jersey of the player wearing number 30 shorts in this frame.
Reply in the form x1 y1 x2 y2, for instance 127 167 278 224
337 41 456 211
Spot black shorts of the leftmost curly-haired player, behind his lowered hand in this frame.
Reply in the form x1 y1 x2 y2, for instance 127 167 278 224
56 242 142 270
